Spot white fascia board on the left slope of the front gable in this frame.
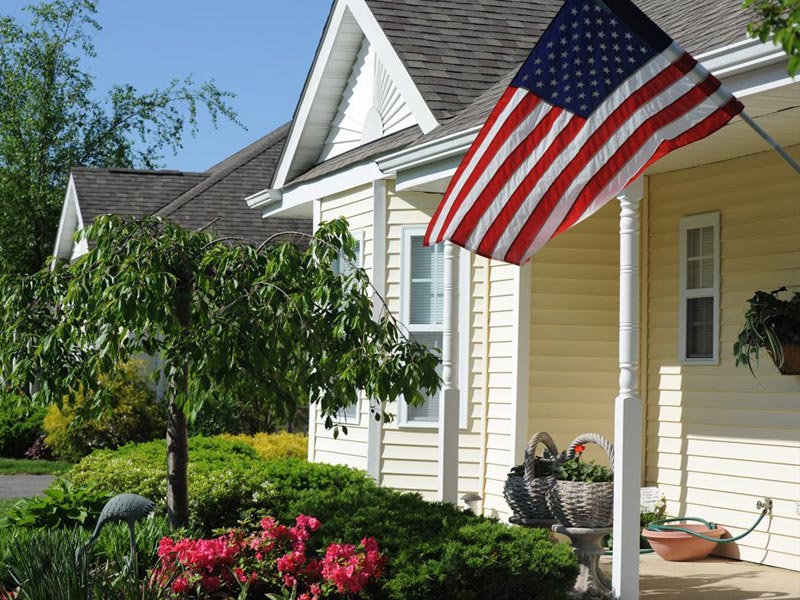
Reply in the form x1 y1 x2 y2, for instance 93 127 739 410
275 0 347 188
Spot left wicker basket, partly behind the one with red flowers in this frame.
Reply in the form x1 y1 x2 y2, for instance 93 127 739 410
503 431 558 519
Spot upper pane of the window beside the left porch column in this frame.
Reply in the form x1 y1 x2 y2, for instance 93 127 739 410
408 235 444 325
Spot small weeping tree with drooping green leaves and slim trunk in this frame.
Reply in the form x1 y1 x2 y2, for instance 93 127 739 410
0 216 440 526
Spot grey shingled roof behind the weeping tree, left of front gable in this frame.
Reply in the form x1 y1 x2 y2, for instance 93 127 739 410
72 124 311 241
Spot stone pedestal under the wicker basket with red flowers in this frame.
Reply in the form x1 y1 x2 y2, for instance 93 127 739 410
553 525 613 600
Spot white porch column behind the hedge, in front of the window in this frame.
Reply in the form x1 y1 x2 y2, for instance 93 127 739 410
437 242 459 504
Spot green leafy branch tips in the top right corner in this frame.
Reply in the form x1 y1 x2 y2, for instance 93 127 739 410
742 0 800 77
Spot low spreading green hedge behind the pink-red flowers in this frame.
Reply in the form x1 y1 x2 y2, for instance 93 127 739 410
62 437 577 600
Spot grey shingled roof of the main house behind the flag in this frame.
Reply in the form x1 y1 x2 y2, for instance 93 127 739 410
291 0 751 183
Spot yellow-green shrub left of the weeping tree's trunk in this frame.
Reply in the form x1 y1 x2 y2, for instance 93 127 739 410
44 361 166 461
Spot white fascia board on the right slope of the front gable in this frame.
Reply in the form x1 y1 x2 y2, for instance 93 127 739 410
345 0 439 133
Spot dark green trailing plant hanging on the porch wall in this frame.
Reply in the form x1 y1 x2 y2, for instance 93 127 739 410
733 287 800 376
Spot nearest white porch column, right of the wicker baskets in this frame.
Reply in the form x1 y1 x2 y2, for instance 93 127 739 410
612 177 644 600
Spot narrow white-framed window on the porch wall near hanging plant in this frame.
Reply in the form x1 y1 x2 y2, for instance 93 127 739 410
679 213 720 364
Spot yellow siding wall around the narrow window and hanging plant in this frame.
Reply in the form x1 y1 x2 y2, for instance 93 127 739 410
646 147 800 570
